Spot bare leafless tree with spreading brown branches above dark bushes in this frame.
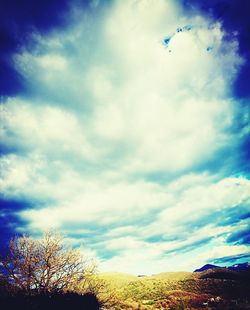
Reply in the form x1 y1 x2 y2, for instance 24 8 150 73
0 232 91 293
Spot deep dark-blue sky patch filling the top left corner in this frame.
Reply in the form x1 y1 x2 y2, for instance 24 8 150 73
0 0 96 96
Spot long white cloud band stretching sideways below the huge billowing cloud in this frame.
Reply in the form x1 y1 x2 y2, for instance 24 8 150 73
14 172 250 232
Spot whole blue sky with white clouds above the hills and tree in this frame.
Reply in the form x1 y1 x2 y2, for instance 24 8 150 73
0 0 250 274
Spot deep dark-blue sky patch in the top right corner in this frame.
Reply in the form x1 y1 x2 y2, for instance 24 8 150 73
182 0 250 98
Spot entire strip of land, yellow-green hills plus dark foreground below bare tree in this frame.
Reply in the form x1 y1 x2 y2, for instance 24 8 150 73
0 267 250 310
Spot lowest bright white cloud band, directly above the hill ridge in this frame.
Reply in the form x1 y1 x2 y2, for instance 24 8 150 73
101 226 249 275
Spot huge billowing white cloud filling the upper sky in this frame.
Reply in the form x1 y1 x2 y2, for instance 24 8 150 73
5 1 241 173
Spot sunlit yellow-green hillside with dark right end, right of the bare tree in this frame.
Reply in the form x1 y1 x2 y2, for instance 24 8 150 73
99 268 250 310
